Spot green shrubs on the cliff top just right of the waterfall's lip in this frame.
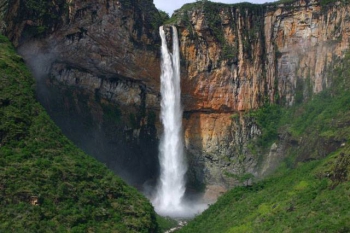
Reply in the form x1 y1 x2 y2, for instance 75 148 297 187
165 0 264 64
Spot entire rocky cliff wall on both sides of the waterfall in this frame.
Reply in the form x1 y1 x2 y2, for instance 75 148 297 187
3 0 350 197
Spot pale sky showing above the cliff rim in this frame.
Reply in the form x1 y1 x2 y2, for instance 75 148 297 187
153 0 276 16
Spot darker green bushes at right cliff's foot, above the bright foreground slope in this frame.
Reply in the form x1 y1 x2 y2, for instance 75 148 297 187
247 53 350 147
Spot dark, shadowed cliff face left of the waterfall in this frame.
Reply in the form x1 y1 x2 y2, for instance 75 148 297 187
2 0 162 185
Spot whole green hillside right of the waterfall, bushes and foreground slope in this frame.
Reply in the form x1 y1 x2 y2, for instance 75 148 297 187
179 55 350 233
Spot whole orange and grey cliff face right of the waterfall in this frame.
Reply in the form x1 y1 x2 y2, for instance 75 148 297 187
173 0 350 192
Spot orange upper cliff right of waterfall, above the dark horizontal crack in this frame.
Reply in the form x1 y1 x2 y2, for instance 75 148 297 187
179 0 350 112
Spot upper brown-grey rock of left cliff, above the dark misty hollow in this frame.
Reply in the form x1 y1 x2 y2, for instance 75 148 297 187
2 0 160 108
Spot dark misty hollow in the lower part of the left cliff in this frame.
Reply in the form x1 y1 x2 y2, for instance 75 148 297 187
17 40 159 187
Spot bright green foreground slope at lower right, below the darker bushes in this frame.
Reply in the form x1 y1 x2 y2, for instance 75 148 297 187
180 147 350 233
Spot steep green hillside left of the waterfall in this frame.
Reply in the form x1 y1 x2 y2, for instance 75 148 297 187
0 36 158 233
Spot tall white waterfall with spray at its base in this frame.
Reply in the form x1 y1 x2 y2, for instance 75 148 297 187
152 26 207 218
